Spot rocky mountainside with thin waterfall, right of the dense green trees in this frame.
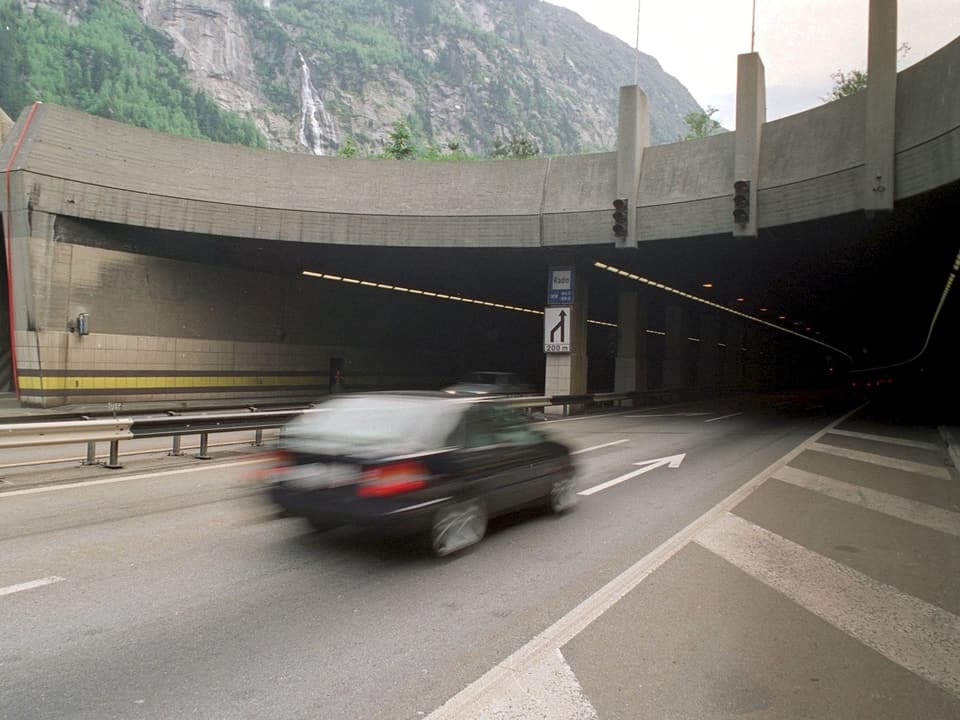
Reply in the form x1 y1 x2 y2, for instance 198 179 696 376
13 0 700 155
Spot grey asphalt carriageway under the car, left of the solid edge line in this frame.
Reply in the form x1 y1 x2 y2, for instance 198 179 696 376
0 396 960 720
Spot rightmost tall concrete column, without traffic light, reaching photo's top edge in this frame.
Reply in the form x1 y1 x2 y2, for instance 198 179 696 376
863 0 897 214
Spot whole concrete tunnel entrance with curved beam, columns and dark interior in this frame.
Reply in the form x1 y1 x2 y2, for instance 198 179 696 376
0 0 960 406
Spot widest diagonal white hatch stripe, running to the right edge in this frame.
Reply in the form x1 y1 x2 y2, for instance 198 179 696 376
696 513 960 695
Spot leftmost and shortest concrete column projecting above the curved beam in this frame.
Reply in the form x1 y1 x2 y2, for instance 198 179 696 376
611 85 650 248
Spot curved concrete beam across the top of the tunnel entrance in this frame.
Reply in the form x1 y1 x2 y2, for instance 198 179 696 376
0 39 960 247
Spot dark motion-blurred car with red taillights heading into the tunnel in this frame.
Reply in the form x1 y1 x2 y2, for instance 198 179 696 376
266 393 577 557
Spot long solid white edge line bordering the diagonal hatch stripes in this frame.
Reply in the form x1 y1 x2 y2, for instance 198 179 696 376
426 405 863 720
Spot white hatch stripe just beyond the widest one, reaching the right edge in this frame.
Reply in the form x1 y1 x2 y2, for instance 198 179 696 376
773 467 960 537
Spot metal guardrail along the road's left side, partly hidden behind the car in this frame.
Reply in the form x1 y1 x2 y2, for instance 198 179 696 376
0 393 652 469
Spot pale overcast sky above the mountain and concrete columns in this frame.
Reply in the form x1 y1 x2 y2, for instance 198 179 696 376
547 0 960 130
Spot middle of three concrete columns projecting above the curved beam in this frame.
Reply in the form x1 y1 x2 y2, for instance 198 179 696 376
729 53 767 237
